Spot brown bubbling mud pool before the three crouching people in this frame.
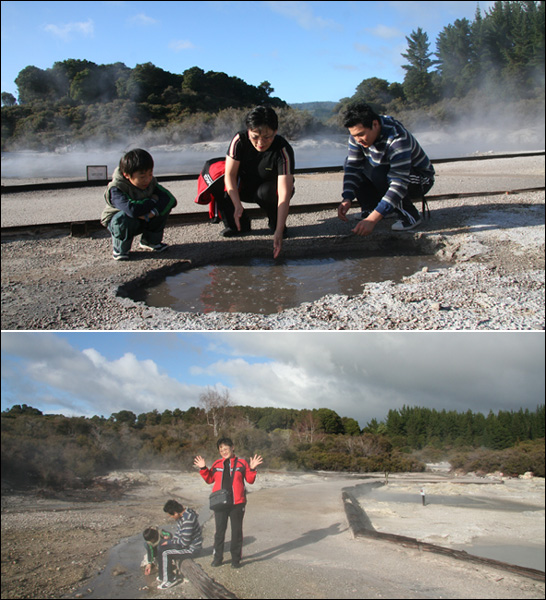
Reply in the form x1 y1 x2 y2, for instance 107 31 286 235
133 255 446 314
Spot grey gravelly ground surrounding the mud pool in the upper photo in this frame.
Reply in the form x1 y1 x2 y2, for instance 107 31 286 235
2 172 544 330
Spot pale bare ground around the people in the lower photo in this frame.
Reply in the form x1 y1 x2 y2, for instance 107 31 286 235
2 471 544 599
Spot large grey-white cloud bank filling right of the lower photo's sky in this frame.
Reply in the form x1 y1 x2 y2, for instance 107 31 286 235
209 332 544 426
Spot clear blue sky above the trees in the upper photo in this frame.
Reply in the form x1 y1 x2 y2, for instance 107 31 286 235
1 1 493 103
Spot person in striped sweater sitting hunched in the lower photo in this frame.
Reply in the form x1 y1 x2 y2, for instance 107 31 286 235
157 500 203 590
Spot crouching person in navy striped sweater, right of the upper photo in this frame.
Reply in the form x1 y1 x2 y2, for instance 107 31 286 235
338 102 434 236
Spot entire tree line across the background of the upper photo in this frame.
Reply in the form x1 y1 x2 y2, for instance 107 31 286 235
2 1 545 150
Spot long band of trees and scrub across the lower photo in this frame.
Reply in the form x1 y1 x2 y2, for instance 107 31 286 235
1 400 544 487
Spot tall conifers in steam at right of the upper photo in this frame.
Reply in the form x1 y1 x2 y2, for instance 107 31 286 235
337 2 545 112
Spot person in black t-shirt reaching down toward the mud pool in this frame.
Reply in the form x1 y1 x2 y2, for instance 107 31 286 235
218 106 294 258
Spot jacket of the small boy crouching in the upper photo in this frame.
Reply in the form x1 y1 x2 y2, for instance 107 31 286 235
100 167 176 227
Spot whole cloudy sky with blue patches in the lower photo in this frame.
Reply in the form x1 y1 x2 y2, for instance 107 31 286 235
2 332 545 427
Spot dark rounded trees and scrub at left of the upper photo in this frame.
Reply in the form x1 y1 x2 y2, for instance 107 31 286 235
2 59 294 150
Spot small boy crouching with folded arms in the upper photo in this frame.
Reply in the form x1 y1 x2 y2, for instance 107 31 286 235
101 148 176 260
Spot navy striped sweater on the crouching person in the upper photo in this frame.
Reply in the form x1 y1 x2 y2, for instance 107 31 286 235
342 116 434 208
